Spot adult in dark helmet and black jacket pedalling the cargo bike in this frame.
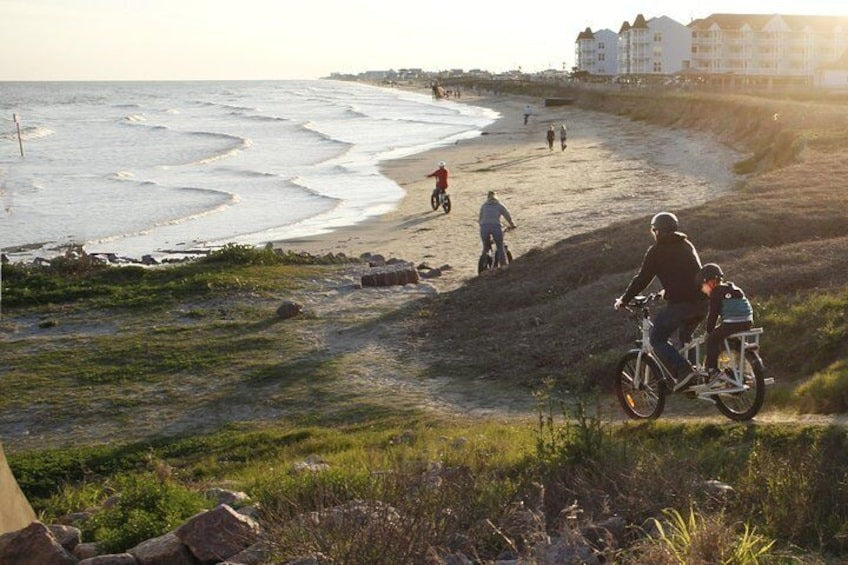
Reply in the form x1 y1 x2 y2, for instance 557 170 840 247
614 212 708 391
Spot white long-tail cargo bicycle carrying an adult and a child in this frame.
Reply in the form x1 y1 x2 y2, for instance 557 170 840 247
614 294 774 421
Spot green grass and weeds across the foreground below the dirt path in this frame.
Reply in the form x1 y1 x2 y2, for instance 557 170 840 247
9 415 848 563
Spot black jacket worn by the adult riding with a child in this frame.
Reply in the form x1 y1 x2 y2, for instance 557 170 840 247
621 232 707 304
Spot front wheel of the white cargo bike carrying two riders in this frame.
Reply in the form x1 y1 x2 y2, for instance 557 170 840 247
615 349 666 420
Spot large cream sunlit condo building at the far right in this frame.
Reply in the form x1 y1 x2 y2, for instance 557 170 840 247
689 14 848 84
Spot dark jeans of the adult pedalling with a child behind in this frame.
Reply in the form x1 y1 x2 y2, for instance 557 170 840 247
650 300 708 378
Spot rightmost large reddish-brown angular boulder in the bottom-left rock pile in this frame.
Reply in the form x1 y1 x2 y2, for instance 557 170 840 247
175 504 259 562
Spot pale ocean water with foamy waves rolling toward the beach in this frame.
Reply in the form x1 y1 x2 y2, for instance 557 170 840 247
0 80 498 260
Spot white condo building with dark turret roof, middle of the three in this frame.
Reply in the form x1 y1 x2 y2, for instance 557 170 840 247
618 14 692 75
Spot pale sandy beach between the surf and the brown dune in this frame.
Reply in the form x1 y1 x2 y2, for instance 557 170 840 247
277 93 742 290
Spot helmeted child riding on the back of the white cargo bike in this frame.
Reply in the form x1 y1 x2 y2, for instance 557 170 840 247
698 263 754 388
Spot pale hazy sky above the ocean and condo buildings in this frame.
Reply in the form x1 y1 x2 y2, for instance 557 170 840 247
0 0 848 81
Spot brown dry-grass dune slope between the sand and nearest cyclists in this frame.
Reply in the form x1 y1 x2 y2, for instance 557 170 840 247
419 87 848 383
